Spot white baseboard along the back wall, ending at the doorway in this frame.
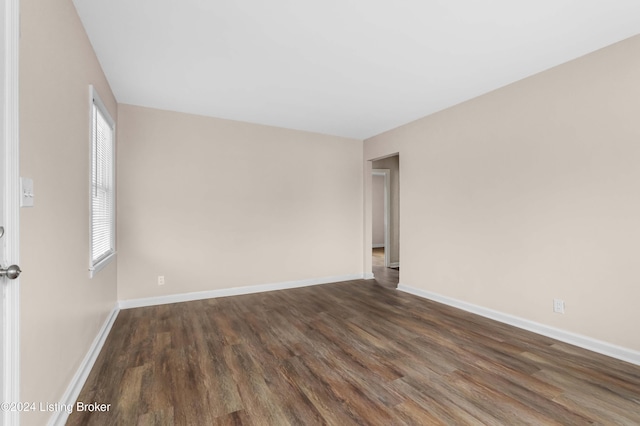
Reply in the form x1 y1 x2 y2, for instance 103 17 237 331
118 274 365 309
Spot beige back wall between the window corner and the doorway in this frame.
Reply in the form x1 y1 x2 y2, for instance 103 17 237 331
118 105 364 300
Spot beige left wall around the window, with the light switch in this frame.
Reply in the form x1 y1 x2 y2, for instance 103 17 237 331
20 0 117 425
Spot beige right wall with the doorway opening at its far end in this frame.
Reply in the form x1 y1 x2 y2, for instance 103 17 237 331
364 36 640 350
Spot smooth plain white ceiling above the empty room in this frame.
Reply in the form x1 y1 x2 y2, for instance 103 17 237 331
74 0 640 139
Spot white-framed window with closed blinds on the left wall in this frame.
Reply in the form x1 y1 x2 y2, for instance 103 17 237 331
89 86 116 277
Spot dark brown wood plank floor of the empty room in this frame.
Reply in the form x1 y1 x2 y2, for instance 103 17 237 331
67 280 640 425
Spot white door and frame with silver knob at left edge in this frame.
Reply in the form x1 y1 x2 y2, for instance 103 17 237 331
0 0 20 425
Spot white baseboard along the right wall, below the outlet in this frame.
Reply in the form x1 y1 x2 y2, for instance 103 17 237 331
398 284 640 365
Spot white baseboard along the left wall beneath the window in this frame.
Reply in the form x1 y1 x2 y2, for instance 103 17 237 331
47 305 120 426
